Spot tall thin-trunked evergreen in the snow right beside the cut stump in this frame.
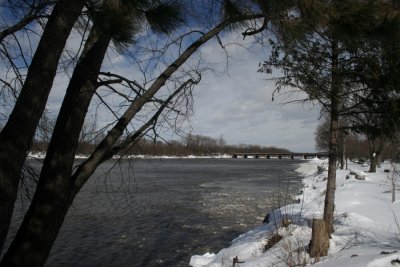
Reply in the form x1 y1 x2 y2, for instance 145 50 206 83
262 0 398 252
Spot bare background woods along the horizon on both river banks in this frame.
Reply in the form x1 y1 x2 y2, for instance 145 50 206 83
27 130 396 160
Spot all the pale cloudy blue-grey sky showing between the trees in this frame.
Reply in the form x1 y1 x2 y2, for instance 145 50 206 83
2 5 320 152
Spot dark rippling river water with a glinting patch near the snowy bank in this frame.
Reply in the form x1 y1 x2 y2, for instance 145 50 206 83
7 159 301 267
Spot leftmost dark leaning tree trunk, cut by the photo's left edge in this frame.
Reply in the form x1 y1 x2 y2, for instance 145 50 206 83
0 0 84 255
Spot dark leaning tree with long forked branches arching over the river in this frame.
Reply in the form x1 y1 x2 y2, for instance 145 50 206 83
0 1 262 266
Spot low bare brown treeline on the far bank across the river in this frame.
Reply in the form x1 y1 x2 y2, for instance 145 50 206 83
31 134 290 156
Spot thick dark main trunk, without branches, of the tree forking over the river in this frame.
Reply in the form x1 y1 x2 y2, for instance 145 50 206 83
1 27 111 266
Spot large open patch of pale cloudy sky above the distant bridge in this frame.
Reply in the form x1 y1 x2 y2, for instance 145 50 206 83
185 32 319 152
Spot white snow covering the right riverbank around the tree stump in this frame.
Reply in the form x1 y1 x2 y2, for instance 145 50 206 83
190 159 400 267
